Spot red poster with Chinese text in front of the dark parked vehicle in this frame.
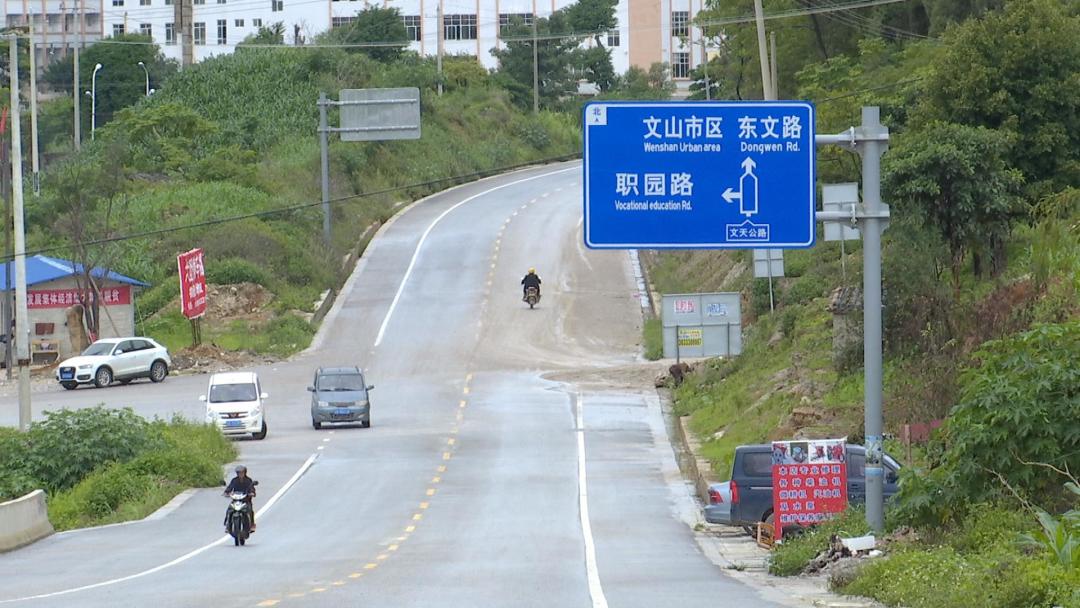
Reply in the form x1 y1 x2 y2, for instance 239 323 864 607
772 440 848 538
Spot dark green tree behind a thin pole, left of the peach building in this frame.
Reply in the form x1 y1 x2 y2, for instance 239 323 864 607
491 11 578 108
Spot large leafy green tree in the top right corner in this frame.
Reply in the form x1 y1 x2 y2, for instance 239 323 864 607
920 0 1080 199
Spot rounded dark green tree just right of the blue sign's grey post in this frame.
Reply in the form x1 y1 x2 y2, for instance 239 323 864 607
882 122 1023 289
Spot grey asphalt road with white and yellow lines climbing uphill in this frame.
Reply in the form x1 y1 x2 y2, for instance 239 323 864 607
0 163 786 608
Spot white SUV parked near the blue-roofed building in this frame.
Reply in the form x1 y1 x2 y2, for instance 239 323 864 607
56 338 173 391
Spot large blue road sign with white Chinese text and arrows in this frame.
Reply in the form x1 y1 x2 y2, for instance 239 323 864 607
584 102 815 248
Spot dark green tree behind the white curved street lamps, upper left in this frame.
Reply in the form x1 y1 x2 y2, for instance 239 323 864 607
44 35 177 129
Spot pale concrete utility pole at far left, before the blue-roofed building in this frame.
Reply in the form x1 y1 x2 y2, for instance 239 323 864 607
8 35 30 431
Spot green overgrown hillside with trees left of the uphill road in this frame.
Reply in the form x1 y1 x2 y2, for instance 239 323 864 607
19 0 671 356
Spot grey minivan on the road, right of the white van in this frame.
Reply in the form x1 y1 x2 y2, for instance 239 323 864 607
308 367 375 431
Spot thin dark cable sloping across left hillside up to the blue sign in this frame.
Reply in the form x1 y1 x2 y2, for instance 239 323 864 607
8 152 581 262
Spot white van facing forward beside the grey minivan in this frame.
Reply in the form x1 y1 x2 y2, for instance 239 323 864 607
199 371 269 440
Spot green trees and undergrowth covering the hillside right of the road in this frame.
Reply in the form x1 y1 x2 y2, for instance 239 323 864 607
642 0 1080 608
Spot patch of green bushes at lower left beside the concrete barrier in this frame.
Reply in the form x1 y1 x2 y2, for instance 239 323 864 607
0 407 237 530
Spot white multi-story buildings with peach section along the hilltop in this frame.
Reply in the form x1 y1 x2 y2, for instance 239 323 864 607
10 0 705 80
